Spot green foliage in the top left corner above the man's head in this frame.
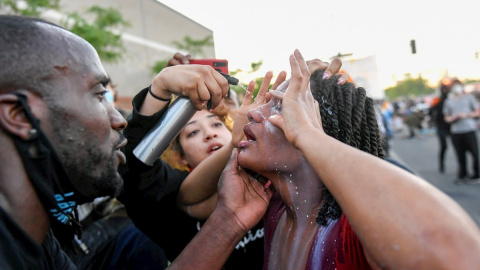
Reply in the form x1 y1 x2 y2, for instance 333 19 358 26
0 0 60 17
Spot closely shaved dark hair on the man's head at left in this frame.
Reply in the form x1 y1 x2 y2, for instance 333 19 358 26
0 15 68 95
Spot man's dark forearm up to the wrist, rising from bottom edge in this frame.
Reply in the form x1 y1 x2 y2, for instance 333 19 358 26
168 210 246 270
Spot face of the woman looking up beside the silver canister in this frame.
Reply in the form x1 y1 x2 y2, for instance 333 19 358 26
179 110 232 168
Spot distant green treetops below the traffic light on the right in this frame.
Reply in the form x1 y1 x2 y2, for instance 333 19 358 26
385 77 435 99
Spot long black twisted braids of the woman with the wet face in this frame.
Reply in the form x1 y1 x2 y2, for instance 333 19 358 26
310 70 384 226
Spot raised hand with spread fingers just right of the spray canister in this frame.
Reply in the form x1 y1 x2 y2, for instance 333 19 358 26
232 71 287 147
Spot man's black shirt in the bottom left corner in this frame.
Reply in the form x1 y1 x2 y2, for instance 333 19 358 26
0 207 76 270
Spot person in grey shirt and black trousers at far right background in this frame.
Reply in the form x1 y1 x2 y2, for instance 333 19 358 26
443 79 480 184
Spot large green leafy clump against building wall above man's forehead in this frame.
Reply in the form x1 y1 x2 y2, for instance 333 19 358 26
64 6 130 62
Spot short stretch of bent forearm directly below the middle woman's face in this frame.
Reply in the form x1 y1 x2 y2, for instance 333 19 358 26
178 144 233 206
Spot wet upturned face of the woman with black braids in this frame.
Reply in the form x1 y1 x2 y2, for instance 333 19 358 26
238 83 301 175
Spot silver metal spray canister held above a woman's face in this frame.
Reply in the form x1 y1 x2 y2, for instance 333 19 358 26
133 72 239 166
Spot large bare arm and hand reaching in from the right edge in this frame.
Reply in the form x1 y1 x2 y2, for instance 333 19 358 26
269 51 480 269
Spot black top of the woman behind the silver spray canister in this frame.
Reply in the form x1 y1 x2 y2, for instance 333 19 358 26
118 88 263 270
